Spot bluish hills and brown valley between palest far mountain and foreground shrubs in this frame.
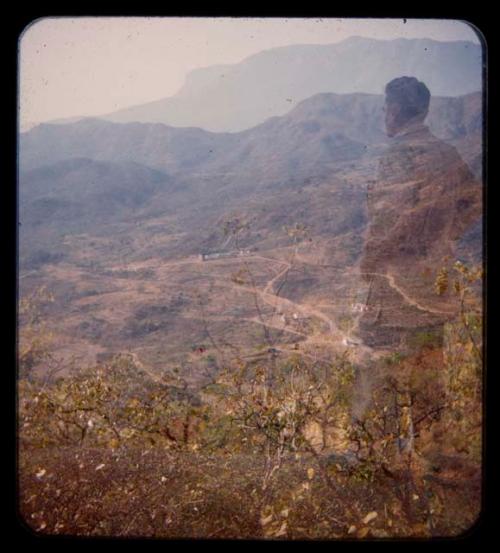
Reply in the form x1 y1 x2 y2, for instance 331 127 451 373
20 88 481 379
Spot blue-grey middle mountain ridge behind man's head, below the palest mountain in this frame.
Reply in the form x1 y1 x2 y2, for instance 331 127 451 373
19 89 482 179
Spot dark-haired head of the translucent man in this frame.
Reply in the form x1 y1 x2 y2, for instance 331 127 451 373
385 77 431 136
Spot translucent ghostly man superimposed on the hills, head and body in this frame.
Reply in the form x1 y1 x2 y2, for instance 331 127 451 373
358 77 481 346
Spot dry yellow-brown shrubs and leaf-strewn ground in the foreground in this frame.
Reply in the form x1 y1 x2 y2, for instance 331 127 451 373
19 264 482 539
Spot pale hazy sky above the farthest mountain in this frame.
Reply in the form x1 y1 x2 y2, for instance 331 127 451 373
19 17 479 129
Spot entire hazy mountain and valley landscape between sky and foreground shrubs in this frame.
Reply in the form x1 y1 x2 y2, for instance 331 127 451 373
19 37 483 376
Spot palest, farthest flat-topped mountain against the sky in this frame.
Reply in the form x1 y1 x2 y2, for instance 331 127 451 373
48 37 482 132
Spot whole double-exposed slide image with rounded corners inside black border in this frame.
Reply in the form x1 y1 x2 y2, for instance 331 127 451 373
16 16 486 542
